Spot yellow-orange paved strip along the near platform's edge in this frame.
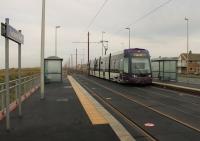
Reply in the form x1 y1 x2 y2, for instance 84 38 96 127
68 76 108 125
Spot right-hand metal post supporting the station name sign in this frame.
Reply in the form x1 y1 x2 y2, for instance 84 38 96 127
18 30 22 117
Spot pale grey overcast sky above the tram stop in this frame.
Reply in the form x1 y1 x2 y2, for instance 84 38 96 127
0 0 200 69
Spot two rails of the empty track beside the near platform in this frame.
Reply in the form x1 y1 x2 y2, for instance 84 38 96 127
74 76 200 140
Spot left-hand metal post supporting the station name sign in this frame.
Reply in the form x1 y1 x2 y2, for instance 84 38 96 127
5 18 10 131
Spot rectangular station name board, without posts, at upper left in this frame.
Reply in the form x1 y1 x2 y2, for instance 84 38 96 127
1 23 24 44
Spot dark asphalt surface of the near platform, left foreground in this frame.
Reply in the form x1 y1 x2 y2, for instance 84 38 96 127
0 77 119 141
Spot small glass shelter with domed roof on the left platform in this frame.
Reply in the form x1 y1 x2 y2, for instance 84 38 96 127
44 56 63 83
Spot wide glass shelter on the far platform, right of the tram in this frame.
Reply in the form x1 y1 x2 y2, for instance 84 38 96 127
151 57 178 81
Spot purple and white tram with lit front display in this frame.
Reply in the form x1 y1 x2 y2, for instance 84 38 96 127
90 48 152 84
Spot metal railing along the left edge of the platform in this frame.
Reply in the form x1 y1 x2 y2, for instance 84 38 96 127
0 74 40 111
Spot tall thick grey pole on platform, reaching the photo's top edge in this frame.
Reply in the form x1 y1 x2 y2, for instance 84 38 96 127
40 0 45 99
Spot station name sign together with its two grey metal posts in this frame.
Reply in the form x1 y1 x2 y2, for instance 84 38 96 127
1 18 24 131
